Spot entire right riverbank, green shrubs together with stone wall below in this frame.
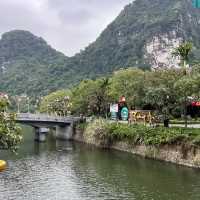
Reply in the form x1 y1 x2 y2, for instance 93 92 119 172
74 119 200 168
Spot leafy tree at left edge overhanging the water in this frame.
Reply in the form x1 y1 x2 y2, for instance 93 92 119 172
0 95 22 152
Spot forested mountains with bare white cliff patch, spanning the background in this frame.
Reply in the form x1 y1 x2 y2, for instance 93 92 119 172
0 0 200 96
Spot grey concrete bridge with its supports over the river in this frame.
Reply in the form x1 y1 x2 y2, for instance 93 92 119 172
16 113 82 142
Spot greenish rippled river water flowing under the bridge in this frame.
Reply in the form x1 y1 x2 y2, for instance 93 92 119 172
0 126 200 200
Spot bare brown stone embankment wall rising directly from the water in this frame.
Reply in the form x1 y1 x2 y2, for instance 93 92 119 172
73 126 200 168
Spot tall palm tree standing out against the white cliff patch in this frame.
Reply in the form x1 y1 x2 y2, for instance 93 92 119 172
173 42 192 128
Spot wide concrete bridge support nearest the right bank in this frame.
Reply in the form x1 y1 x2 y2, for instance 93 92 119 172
56 123 74 140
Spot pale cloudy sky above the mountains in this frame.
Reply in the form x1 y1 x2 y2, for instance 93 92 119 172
0 0 133 56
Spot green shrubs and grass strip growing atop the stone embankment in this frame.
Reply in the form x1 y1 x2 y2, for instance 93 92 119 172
82 119 200 146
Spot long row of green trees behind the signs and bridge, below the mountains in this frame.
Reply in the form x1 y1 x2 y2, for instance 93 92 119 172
37 65 200 119
